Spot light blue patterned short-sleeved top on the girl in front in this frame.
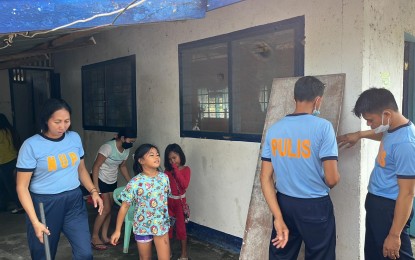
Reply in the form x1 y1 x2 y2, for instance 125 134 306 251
120 172 170 236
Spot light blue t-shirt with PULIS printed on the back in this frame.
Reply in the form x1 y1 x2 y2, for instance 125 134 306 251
262 114 338 198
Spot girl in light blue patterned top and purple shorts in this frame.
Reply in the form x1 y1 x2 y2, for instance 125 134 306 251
111 144 170 260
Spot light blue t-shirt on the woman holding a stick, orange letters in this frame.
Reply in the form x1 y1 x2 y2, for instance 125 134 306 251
16 131 84 194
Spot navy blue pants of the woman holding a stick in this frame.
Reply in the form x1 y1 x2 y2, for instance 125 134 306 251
26 188 93 260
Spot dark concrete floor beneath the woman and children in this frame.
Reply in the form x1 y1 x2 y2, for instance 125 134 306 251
0 205 239 260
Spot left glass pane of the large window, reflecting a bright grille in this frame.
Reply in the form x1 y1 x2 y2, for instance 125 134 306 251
181 43 229 132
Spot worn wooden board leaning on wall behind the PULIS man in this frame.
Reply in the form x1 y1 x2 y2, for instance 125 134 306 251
239 74 346 260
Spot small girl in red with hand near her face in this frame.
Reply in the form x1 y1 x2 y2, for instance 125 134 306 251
164 144 191 260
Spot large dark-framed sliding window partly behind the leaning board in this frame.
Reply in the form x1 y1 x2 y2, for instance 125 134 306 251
179 17 304 142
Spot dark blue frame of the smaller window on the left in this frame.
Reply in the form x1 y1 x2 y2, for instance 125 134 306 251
81 55 137 132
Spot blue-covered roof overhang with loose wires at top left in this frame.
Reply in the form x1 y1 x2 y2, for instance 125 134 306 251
0 0 243 69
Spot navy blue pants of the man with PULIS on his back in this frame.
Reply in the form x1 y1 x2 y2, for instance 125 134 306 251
269 193 336 260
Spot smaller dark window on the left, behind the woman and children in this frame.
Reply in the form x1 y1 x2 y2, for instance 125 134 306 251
82 55 137 132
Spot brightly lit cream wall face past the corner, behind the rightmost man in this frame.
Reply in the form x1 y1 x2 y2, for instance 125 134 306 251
360 0 415 256
